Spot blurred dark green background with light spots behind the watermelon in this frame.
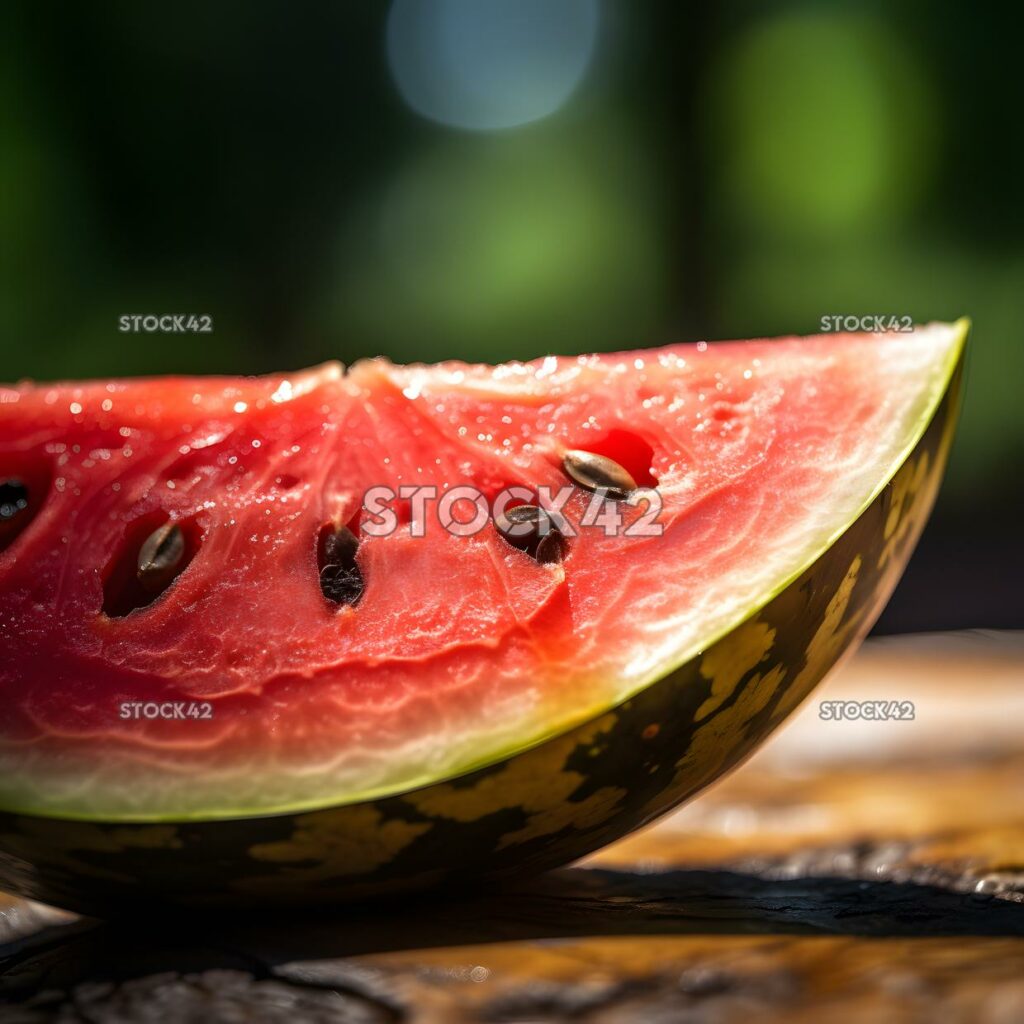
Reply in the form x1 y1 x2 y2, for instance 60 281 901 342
0 0 1024 630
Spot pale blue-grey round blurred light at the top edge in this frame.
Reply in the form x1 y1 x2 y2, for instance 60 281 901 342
387 0 599 130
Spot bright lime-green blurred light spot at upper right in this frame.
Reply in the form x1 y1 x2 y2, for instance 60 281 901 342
709 9 935 234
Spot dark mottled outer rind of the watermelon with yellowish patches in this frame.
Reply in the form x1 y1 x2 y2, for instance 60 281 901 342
0 360 963 911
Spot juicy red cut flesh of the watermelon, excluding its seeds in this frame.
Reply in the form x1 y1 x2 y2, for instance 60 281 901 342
0 325 962 820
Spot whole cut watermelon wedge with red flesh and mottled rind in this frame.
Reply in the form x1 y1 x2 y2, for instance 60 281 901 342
0 322 967 908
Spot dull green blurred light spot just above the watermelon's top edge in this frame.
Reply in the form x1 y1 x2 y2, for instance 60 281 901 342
329 130 666 360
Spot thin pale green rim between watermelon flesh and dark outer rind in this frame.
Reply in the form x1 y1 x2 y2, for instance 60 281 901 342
5 317 971 824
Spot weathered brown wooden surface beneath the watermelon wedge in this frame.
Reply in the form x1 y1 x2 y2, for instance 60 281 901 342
0 634 1024 1024
